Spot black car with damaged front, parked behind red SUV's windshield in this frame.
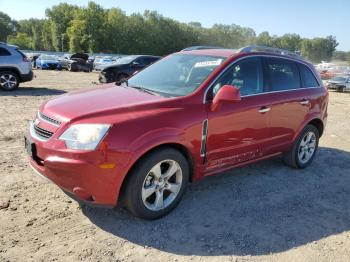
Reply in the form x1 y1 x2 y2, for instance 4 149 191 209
98 55 160 83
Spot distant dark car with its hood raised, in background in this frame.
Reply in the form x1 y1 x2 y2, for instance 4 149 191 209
60 53 93 72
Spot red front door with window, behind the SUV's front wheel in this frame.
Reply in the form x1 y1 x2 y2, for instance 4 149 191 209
206 57 270 172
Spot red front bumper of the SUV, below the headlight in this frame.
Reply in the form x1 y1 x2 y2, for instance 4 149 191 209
25 131 130 207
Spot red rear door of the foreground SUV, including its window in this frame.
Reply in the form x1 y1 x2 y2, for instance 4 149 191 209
263 57 318 153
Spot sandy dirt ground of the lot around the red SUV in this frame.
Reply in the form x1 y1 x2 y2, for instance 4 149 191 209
0 71 350 262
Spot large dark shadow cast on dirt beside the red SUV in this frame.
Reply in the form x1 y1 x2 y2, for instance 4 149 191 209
82 147 350 256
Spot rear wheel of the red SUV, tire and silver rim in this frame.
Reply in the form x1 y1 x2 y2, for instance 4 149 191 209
283 125 320 169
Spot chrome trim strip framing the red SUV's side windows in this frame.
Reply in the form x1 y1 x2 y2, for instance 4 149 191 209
203 54 322 104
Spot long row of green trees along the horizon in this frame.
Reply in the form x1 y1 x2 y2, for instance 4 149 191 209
0 2 349 62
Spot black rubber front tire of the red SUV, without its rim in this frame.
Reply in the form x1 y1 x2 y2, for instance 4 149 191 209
125 149 190 220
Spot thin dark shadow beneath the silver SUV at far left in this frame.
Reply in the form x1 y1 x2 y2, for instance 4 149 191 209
0 87 66 97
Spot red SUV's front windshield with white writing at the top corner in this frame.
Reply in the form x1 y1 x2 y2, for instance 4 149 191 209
128 54 225 96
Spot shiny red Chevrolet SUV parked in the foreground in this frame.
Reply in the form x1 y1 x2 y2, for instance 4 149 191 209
26 46 328 219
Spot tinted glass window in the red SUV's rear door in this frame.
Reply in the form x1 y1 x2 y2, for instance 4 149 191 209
264 58 301 91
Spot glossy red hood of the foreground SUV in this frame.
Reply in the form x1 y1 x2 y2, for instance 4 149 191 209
40 83 167 122
